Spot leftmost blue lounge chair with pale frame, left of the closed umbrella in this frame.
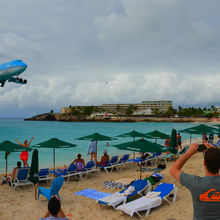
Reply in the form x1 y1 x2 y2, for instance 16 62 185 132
11 167 33 189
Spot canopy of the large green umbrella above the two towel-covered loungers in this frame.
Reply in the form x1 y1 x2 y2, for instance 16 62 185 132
113 138 167 153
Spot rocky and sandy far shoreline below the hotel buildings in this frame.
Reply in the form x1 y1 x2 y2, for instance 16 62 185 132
24 113 220 123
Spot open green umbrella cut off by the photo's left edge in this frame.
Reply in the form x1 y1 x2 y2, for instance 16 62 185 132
0 140 32 180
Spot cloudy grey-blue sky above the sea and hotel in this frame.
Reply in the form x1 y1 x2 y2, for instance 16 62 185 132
0 0 220 117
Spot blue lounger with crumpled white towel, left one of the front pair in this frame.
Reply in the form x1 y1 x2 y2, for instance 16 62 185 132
98 179 151 208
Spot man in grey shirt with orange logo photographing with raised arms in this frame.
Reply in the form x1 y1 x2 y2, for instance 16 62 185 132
170 142 220 220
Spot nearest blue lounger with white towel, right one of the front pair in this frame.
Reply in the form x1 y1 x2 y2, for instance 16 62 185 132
117 183 177 217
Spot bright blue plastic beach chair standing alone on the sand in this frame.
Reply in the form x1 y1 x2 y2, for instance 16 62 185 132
38 176 64 200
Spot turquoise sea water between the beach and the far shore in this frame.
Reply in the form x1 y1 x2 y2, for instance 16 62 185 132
0 119 203 173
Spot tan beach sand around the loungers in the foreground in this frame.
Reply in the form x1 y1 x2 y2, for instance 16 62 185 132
0 141 204 220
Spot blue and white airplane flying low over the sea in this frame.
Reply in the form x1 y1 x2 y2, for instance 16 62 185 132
0 60 27 87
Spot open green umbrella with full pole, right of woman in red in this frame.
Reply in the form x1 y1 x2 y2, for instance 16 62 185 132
32 138 76 175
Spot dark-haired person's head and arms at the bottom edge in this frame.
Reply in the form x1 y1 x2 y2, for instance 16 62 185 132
40 196 68 220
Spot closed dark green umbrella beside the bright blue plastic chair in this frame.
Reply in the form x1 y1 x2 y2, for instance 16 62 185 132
29 149 39 200
